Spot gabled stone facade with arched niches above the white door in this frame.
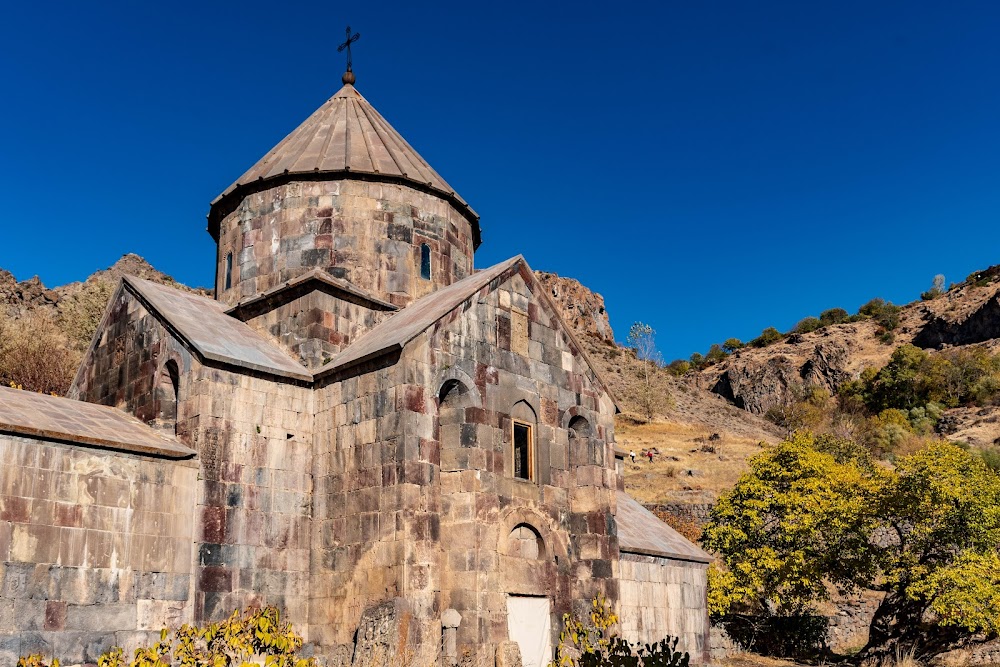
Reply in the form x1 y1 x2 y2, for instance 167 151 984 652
412 265 618 662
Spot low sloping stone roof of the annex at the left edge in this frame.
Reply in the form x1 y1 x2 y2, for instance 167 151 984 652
0 387 195 459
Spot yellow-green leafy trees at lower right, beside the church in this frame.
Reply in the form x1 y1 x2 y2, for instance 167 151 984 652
704 432 1000 649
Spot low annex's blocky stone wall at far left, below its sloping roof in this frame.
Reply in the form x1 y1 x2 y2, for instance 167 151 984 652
0 434 198 665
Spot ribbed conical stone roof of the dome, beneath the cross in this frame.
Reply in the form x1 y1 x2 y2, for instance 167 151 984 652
208 84 480 246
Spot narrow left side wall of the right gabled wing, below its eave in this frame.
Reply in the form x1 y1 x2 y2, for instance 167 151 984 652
309 358 410 659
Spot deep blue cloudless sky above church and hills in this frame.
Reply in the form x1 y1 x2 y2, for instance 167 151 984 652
0 0 1000 359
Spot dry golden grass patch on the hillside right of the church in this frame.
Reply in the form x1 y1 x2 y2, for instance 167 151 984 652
615 419 761 503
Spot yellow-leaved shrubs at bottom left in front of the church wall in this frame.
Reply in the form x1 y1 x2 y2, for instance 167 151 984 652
17 607 316 667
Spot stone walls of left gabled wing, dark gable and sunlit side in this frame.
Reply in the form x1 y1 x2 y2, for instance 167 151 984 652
73 291 313 627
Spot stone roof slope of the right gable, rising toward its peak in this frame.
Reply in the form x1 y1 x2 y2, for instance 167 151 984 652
316 255 524 377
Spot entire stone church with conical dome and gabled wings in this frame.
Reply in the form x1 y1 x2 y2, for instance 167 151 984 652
0 66 709 667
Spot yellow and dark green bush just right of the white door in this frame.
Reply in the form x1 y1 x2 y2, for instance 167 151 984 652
549 595 690 667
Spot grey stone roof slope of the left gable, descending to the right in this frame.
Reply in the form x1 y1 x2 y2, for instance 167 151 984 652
123 276 312 381
